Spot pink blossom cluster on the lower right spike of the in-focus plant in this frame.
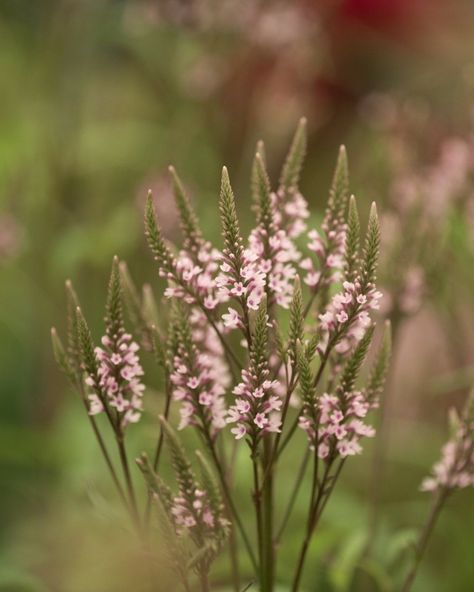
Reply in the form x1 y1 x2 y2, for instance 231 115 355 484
299 391 377 459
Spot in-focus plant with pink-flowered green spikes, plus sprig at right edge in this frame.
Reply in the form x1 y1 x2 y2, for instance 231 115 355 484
52 120 474 592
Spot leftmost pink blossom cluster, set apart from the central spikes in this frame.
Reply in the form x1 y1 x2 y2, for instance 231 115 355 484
86 332 145 428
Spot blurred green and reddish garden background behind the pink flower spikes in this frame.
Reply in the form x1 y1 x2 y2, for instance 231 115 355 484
0 0 474 592
